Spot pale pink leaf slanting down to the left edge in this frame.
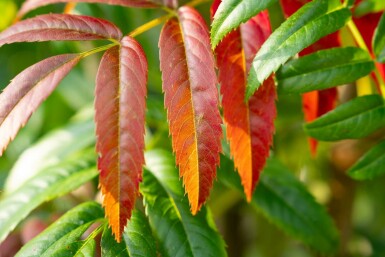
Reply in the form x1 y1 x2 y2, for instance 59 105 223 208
0 54 81 156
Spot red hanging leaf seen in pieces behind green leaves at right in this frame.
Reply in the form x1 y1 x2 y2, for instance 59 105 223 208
281 0 341 156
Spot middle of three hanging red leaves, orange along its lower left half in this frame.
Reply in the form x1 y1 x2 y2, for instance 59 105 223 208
159 7 222 214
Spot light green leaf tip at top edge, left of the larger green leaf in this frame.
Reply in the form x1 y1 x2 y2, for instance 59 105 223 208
211 0 277 49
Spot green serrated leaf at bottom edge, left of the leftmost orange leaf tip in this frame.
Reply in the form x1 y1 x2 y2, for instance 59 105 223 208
16 202 104 257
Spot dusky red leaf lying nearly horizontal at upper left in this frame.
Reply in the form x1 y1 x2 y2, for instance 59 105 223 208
0 14 122 46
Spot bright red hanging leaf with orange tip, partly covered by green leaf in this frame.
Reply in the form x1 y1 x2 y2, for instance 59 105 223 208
216 4 276 201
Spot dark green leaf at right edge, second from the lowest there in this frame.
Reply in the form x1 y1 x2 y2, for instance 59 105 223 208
304 95 385 141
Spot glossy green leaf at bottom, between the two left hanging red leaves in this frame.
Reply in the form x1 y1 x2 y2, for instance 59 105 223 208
141 150 227 257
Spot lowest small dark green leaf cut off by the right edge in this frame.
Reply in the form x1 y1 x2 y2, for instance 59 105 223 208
348 141 385 180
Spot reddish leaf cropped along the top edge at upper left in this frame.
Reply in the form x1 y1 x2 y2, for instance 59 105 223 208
18 0 157 18
